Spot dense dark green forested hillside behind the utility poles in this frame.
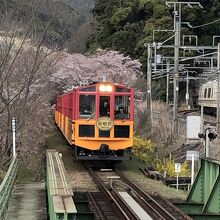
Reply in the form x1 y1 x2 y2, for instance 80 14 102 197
87 0 220 99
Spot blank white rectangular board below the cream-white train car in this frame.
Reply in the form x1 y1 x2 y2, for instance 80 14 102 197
186 116 201 139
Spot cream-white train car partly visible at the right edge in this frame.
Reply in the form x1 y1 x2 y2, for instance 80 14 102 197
198 80 218 114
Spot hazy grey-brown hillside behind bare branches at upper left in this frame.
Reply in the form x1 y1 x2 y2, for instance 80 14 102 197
0 0 93 51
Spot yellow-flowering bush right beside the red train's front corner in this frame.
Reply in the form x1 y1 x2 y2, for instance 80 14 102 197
132 135 155 162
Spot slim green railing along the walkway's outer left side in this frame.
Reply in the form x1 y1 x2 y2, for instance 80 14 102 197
0 156 18 219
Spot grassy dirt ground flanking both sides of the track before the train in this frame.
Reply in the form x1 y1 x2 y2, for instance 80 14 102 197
46 129 186 199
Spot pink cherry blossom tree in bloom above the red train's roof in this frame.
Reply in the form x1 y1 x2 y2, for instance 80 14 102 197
53 50 143 89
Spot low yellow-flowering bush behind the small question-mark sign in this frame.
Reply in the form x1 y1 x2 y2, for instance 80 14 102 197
155 158 190 177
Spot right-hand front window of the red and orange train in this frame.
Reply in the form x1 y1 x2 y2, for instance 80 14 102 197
115 95 130 119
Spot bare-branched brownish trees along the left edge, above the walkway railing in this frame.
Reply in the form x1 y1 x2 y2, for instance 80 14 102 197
0 0 60 169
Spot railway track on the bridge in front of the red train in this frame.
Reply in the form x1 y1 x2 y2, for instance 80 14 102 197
87 167 191 220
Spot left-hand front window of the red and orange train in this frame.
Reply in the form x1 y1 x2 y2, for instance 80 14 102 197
79 95 96 118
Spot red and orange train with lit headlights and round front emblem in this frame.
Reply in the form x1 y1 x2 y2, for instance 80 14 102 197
55 82 134 161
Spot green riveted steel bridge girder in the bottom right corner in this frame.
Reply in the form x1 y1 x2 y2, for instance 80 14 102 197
176 158 220 220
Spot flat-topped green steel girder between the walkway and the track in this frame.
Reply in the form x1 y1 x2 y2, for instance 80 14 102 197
47 150 77 220
